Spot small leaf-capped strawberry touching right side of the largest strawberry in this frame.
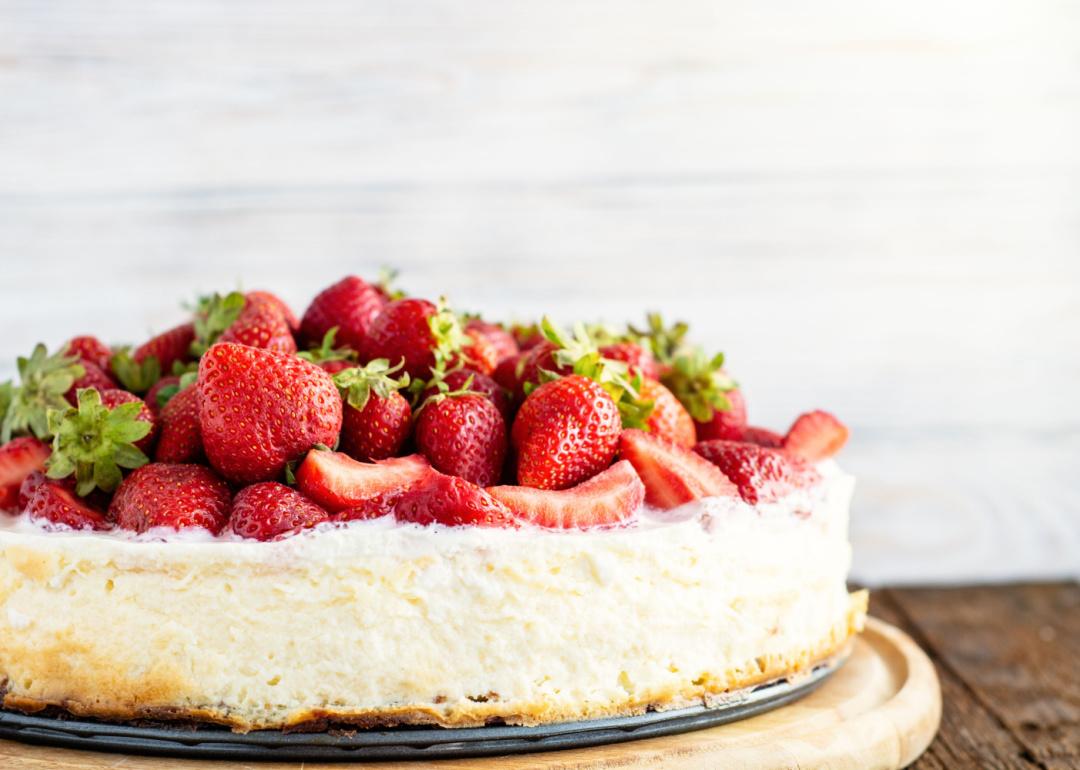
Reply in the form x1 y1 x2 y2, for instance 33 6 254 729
334 359 413 460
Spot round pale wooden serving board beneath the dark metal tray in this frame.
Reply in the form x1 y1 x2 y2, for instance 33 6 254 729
0 618 941 770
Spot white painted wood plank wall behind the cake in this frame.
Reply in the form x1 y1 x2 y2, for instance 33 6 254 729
0 0 1080 583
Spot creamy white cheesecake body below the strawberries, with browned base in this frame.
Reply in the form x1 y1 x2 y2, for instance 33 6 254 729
0 463 865 729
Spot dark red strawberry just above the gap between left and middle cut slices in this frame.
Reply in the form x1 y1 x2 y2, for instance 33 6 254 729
416 393 507 486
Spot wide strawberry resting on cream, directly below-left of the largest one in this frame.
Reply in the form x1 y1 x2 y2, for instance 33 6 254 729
109 462 232 535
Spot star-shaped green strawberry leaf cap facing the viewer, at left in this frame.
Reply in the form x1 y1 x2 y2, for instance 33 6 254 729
45 388 151 496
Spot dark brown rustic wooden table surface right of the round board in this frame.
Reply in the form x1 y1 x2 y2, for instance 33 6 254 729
870 583 1080 770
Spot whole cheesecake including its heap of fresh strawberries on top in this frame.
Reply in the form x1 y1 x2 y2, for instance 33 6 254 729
0 276 866 731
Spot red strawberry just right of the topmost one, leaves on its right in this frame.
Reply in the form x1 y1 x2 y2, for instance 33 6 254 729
361 299 438 379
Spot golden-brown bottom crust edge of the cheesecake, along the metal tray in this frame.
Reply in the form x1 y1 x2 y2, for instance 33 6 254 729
2 591 868 732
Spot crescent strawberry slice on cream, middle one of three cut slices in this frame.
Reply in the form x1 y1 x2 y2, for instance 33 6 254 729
488 460 645 529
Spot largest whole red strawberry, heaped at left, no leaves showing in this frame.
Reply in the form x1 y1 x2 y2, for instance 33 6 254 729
199 342 341 483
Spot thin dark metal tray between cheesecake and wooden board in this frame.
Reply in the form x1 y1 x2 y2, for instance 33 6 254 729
0 659 843 761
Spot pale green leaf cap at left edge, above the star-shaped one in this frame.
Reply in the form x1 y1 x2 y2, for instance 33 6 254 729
0 343 86 444
